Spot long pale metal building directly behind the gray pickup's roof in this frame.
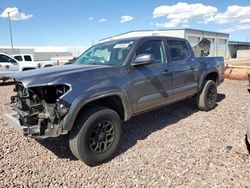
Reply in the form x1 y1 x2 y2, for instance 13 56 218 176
100 29 229 58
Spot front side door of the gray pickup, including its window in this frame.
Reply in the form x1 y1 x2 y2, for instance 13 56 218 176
128 40 172 113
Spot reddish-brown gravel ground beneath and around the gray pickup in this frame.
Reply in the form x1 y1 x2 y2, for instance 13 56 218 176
0 80 250 187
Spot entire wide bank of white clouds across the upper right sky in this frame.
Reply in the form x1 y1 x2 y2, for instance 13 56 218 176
153 2 250 32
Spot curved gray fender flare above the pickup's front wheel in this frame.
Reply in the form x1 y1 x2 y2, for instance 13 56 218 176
64 90 132 131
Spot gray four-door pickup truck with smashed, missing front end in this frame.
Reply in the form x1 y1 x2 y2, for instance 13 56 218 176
6 36 224 166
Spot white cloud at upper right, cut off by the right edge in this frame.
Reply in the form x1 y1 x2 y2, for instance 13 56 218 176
205 5 250 24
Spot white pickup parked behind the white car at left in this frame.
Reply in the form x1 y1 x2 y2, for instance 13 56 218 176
12 54 58 68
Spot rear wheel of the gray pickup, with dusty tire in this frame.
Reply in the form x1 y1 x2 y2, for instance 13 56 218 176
195 80 217 111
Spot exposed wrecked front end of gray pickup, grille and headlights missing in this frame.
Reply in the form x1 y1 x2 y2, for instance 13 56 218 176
11 82 71 139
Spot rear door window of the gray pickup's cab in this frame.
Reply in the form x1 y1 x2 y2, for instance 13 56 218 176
168 40 190 62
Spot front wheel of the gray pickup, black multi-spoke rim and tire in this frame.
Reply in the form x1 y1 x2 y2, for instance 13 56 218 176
69 107 122 166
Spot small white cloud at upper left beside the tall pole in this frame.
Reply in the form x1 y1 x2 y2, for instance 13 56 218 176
0 7 33 20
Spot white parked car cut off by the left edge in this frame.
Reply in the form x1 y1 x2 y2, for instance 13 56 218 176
0 53 39 81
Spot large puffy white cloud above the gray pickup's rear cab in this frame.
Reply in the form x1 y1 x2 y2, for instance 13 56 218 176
153 2 217 27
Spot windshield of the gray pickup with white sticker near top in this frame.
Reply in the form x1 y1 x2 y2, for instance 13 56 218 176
74 41 134 65
